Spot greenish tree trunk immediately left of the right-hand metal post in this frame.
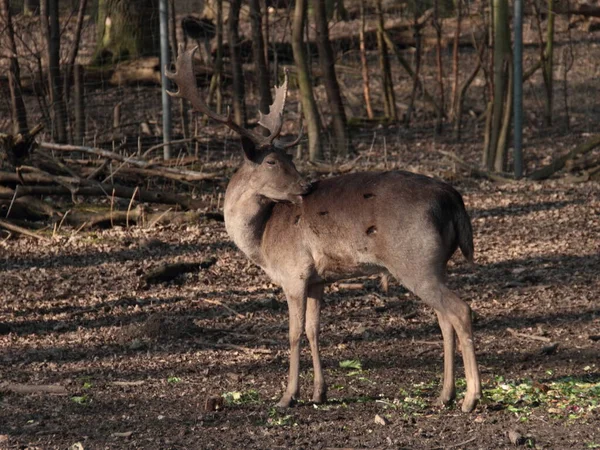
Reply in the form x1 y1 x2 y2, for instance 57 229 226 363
484 0 512 172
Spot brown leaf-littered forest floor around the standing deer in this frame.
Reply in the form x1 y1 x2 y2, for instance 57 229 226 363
0 6 600 449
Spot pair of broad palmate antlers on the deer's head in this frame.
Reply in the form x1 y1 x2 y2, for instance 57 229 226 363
165 46 287 146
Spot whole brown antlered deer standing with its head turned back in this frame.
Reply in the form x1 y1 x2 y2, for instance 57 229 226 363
165 49 481 412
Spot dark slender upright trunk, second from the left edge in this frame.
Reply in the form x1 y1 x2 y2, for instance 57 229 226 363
41 0 67 142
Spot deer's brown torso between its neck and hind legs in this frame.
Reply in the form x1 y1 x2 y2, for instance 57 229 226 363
263 171 464 281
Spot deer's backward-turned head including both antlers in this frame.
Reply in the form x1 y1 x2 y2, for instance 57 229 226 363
165 48 310 203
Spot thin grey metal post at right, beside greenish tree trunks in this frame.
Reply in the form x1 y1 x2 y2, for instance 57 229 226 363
513 0 523 179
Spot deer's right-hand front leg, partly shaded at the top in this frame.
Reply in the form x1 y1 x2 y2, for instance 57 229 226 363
306 284 327 403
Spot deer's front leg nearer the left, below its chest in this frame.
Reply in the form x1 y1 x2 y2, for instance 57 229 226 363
277 286 306 408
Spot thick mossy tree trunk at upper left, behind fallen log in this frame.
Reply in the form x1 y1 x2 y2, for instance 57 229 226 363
93 0 160 65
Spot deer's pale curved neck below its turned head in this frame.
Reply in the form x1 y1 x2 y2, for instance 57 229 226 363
224 173 273 267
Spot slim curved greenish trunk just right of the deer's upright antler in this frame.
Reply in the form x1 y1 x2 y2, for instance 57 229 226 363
292 0 322 161
